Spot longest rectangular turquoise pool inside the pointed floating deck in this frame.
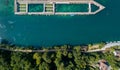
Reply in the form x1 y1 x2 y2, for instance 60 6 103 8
56 4 88 12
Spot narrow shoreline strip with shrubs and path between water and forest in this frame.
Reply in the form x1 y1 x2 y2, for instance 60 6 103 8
0 39 120 53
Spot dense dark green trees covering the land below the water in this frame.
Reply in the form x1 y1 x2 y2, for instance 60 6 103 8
0 44 120 70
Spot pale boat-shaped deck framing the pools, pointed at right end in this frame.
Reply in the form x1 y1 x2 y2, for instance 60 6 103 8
14 0 105 15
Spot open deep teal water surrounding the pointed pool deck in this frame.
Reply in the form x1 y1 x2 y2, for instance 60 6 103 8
0 0 120 46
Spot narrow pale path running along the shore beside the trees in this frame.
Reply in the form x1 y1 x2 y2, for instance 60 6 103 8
0 41 120 53
